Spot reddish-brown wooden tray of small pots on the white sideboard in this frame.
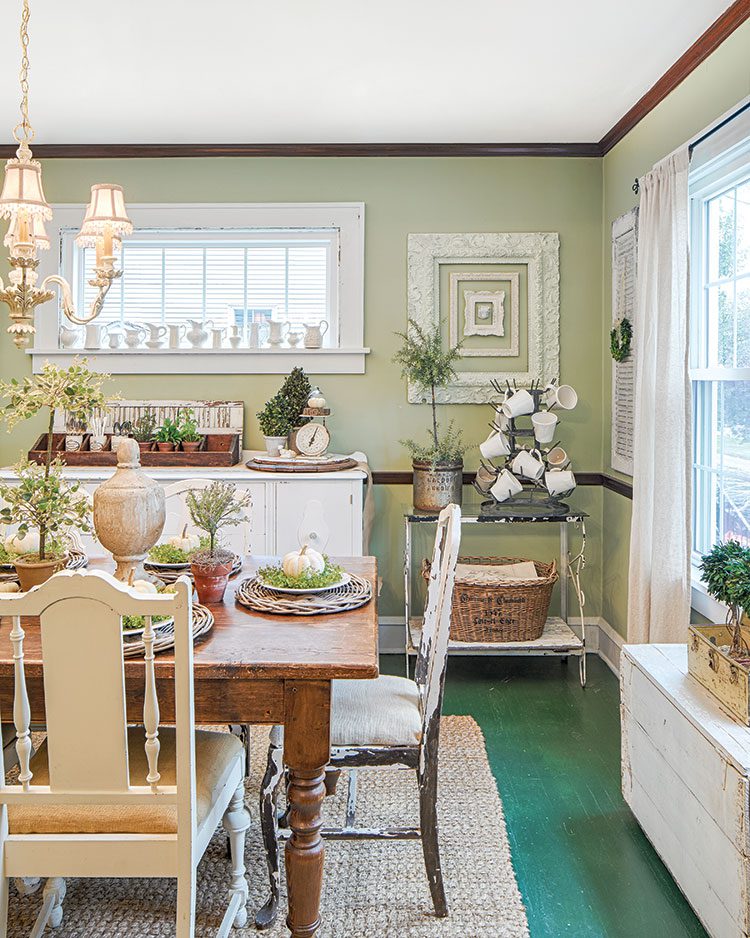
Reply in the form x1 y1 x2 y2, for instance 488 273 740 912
29 433 240 468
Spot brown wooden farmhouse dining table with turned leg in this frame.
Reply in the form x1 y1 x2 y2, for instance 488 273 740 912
0 557 378 938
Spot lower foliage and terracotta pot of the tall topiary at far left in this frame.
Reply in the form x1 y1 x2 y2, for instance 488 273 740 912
0 459 91 592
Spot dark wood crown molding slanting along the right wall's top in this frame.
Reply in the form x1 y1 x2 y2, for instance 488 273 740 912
599 0 750 156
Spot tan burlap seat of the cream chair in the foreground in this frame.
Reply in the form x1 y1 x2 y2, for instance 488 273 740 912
8 727 244 834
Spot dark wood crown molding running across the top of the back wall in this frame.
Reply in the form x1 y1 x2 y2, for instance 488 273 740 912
0 143 601 159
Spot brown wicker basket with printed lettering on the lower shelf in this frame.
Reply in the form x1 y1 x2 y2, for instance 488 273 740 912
422 557 558 643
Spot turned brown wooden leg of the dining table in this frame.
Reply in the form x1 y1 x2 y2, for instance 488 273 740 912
284 681 331 938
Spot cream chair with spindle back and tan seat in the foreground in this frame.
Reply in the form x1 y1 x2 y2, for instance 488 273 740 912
0 571 250 938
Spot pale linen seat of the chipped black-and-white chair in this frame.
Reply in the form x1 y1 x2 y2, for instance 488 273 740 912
331 674 422 746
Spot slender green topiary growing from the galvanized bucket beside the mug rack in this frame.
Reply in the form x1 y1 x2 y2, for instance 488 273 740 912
393 318 468 465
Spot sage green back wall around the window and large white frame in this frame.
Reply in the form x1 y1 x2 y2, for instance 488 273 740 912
0 158 602 615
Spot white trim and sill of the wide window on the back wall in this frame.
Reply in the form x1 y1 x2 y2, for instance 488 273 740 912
27 202 370 374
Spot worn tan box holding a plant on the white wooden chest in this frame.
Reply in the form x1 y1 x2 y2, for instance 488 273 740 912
688 625 750 726
